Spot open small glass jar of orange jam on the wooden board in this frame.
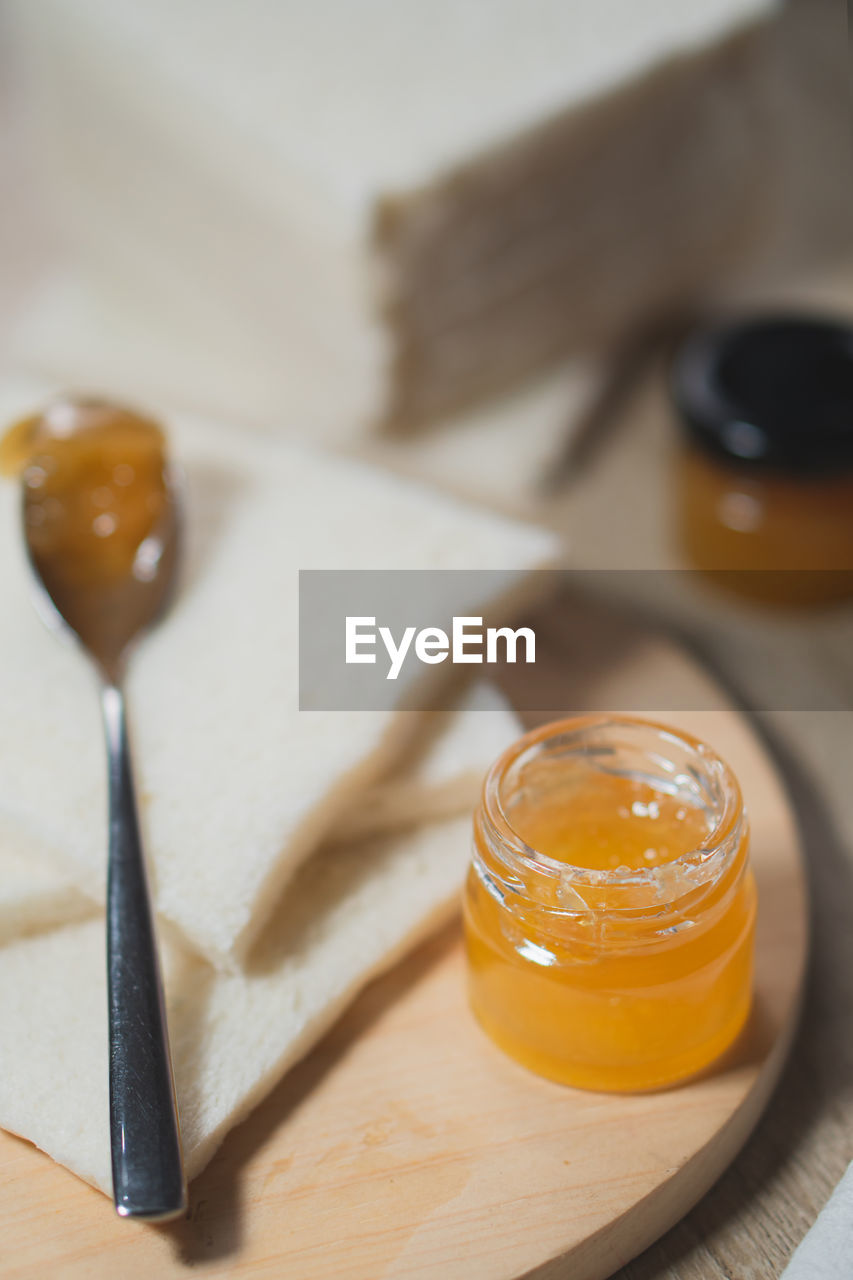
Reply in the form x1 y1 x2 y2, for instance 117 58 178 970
465 717 756 1091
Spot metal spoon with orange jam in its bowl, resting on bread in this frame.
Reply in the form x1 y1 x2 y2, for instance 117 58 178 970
13 399 187 1220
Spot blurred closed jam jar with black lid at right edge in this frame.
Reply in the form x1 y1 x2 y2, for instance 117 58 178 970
672 315 853 605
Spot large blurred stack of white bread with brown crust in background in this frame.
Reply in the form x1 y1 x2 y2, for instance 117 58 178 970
6 0 775 443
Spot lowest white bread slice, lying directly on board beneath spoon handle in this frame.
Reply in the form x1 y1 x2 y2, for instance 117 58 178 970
0 808 471 1190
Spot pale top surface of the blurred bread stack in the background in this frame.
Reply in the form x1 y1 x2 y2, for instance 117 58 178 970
9 0 771 225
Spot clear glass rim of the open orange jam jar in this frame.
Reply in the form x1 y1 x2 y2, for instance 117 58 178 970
479 713 747 914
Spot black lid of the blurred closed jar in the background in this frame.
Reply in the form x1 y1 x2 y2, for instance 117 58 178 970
672 315 853 475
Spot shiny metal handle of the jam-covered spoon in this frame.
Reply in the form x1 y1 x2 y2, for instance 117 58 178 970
101 684 187 1219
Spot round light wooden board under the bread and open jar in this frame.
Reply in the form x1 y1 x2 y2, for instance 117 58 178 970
0 608 807 1280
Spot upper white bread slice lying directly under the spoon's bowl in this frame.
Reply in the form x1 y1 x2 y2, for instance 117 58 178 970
0 384 555 966
